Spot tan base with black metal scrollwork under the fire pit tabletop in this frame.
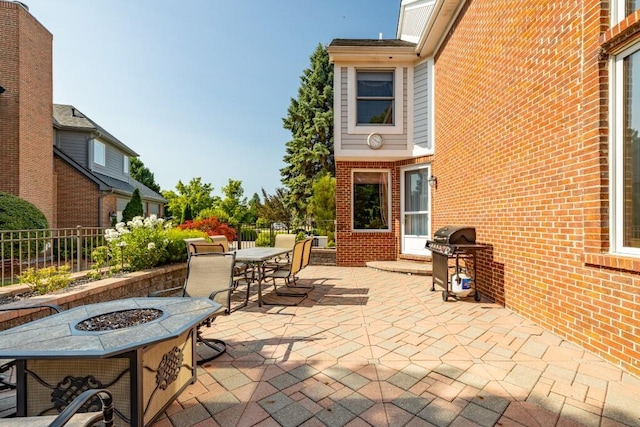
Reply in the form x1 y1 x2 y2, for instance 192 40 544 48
22 330 195 426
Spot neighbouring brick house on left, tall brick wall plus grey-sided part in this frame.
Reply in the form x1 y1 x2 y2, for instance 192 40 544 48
0 0 166 228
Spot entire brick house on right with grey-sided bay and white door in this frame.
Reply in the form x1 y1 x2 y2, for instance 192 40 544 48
328 0 640 382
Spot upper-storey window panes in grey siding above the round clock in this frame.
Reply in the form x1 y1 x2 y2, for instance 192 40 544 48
356 71 394 125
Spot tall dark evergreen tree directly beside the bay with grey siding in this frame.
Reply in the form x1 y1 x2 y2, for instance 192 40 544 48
280 44 335 221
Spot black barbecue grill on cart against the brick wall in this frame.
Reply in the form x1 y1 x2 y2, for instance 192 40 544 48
426 225 488 301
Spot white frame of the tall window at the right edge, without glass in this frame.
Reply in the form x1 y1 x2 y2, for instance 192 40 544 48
609 43 640 256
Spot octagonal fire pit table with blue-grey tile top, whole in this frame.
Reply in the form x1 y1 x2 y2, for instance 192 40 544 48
0 297 220 426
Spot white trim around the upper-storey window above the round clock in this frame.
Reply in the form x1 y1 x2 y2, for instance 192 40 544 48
347 66 404 135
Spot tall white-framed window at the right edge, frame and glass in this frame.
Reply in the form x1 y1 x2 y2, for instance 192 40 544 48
611 43 640 255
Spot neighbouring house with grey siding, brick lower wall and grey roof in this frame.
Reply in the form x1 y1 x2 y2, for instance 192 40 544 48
53 104 166 227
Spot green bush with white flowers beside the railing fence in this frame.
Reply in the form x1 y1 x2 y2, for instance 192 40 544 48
93 215 172 271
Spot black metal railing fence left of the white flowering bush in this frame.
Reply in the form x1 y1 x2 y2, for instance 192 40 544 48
0 226 105 286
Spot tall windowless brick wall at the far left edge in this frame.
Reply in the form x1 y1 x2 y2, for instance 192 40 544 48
0 1 55 226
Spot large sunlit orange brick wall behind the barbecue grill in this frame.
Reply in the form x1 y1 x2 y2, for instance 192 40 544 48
432 0 640 375
